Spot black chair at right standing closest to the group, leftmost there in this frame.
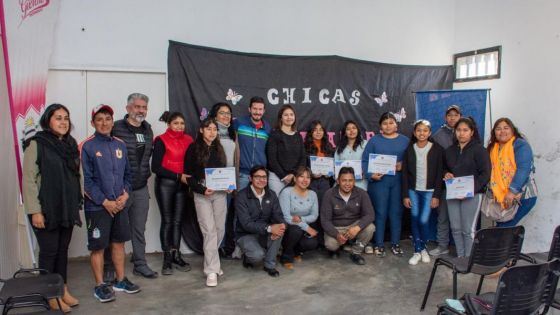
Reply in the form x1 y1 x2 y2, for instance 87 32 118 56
420 226 525 311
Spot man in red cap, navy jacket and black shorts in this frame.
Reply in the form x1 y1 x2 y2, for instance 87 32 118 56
80 104 140 302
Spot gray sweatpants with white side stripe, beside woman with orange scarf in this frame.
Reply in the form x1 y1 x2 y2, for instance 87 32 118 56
447 194 482 257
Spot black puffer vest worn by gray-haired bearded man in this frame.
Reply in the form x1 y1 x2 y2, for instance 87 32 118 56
112 115 154 190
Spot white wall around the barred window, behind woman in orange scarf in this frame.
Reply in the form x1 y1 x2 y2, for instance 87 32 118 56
453 0 560 251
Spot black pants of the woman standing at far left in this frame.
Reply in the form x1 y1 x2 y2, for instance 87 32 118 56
33 227 74 283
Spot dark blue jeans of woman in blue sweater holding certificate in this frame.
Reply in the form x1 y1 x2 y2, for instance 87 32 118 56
368 173 403 247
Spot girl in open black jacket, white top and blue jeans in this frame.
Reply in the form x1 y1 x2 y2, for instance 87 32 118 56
402 120 443 265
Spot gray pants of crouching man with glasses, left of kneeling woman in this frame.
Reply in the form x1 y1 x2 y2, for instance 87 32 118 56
237 233 282 269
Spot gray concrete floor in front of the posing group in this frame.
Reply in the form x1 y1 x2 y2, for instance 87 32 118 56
59 241 528 315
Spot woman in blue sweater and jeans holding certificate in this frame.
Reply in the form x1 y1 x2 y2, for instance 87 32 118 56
362 112 409 257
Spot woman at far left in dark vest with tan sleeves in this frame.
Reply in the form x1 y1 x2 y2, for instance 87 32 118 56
23 104 83 313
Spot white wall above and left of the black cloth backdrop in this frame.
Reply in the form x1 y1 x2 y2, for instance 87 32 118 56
47 0 455 256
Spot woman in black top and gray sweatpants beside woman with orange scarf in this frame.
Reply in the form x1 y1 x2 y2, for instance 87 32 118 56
443 117 491 257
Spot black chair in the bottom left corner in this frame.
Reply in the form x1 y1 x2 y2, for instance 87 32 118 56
0 269 64 313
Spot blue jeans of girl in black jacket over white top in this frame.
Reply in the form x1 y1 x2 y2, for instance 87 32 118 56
408 189 434 253
